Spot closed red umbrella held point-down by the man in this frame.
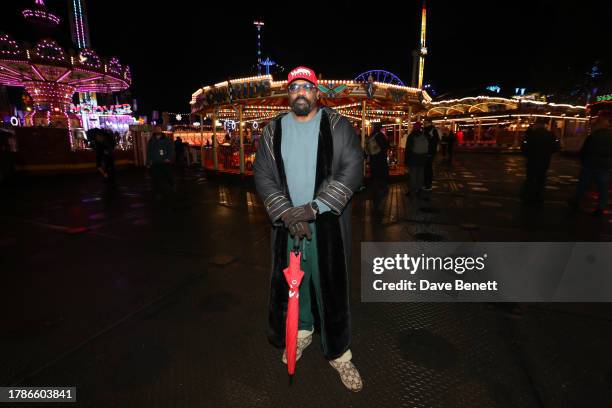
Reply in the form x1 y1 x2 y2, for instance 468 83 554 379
283 238 304 380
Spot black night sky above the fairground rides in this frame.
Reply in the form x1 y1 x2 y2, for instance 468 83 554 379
0 0 612 115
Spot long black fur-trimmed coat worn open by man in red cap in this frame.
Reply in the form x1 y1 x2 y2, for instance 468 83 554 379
253 108 363 359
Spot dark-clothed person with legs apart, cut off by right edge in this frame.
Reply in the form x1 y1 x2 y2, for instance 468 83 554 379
569 116 612 217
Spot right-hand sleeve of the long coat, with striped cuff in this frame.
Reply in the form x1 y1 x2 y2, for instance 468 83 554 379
317 118 363 215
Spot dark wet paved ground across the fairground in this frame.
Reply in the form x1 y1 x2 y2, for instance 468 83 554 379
0 154 612 408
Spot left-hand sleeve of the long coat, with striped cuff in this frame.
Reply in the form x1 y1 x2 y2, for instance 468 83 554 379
253 124 293 226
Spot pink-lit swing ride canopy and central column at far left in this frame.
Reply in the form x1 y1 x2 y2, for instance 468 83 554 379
0 0 132 128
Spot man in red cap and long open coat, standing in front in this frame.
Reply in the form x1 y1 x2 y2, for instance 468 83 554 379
253 67 363 391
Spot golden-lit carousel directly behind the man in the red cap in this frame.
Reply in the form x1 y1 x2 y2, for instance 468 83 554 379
185 71 431 175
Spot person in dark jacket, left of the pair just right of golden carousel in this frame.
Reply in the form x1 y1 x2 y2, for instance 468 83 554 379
404 122 429 198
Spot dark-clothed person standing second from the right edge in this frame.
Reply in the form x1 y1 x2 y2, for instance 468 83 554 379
521 118 560 205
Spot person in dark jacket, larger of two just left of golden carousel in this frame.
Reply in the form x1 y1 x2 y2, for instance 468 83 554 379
147 131 174 199
